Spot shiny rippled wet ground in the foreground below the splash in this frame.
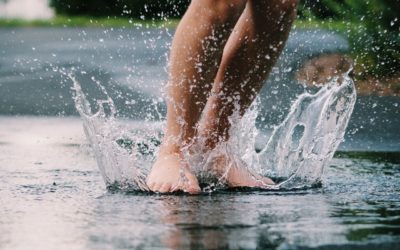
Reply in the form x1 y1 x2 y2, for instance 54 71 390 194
0 124 400 249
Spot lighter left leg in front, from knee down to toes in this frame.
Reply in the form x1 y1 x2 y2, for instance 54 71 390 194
147 0 246 193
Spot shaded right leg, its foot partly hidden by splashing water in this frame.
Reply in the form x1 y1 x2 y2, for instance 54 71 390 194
199 0 297 186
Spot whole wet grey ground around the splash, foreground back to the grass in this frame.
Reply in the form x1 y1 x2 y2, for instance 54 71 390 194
0 29 400 249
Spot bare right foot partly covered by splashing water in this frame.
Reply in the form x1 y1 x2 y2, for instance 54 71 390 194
214 156 275 188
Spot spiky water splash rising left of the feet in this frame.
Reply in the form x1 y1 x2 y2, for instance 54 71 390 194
68 74 161 190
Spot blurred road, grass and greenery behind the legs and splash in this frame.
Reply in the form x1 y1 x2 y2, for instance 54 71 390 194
0 0 400 151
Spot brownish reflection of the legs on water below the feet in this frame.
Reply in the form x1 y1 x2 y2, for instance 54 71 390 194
159 196 255 249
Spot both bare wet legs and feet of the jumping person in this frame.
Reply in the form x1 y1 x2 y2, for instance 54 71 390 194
147 0 297 193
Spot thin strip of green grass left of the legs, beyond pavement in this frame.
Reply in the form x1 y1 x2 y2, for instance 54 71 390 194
0 16 179 28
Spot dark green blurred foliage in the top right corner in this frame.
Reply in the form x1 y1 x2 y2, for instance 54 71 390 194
298 0 400 76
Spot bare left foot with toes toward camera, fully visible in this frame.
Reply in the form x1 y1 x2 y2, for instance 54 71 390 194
147 153 201 194
